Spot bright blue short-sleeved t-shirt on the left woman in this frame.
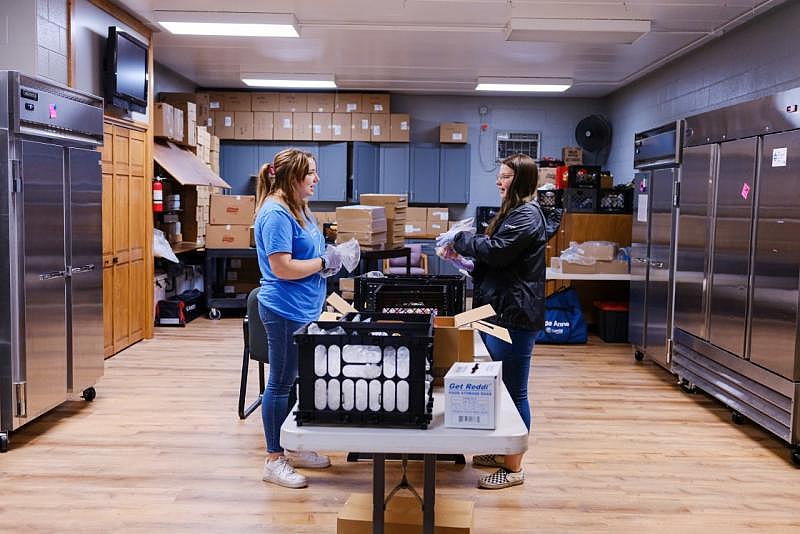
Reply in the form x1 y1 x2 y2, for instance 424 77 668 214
255 199 325 323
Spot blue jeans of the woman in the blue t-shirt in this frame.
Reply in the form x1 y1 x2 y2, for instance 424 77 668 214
258 303 305 452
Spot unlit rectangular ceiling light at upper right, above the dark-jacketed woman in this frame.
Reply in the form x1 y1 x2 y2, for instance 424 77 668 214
506 18 650 44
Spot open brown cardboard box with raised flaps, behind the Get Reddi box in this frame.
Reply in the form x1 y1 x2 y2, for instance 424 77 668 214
432 304 511 386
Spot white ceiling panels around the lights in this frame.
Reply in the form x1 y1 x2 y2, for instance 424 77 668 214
116 0 786 97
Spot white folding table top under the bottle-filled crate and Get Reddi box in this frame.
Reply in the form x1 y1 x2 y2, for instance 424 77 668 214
281 386 528 454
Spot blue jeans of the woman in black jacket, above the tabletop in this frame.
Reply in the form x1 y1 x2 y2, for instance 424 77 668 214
481 329 536 432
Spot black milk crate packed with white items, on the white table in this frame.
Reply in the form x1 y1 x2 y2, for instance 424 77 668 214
294 312 433 429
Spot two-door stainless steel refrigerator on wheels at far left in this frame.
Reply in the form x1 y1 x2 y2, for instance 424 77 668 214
0 71 103 451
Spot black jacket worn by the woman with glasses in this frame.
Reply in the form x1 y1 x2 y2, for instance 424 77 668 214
453 201 561 331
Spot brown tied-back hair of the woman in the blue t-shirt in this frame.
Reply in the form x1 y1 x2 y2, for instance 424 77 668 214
256 148 314 228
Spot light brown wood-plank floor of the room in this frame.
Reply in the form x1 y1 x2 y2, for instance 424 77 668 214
0 319 800 533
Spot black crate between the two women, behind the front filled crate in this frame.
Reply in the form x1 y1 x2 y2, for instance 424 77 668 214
353 274 466 316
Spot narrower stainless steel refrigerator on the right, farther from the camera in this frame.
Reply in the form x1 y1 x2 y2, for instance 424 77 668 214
628 123 681 369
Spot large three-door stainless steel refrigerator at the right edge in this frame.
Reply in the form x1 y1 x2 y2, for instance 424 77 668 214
672 89 800 463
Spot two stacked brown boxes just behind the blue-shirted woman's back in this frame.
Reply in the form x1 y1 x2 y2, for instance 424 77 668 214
206 195 256 248
